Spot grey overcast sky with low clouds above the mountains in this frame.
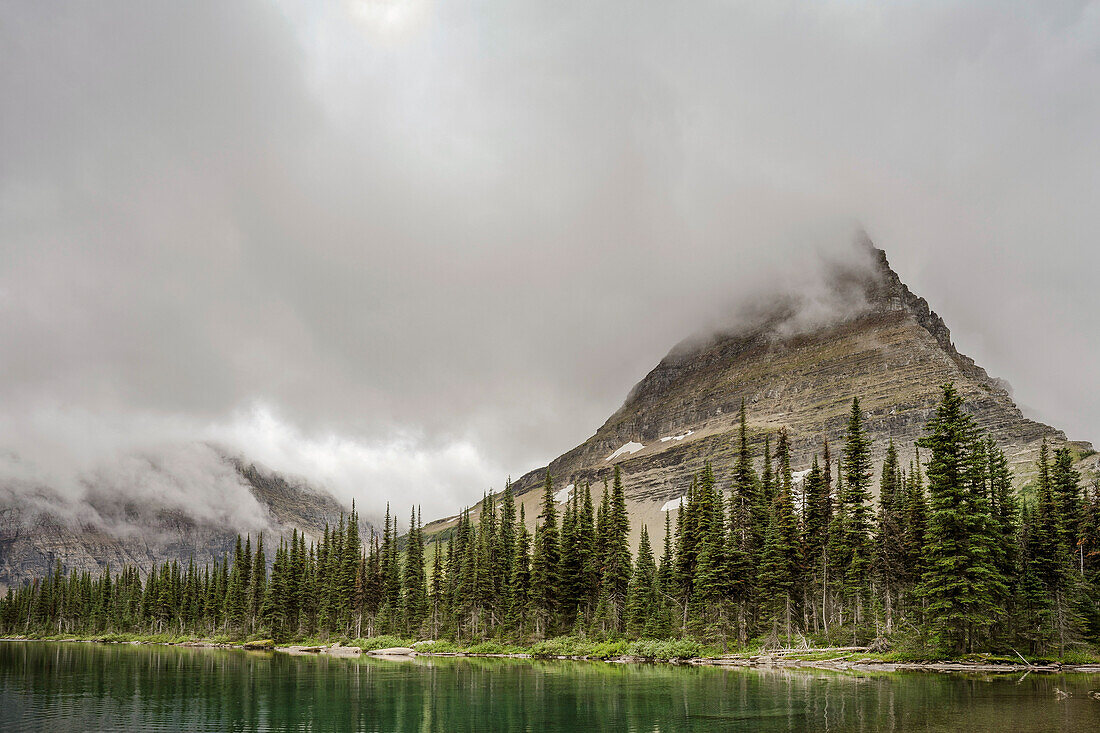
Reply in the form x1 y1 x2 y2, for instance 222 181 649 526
0 0 1100 516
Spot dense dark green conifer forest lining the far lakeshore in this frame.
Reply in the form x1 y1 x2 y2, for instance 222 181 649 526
0 385 1100 656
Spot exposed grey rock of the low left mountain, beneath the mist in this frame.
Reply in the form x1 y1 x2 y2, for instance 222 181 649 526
0 444 371 592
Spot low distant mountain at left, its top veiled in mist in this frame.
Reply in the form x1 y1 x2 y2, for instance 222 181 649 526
0 444 371 591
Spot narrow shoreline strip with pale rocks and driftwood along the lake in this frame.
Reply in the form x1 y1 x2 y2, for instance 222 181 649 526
8 637 1100 675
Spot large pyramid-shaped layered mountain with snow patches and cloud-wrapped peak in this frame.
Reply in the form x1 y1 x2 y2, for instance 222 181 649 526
425 240 1100 541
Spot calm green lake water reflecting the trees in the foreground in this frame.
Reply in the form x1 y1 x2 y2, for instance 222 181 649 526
0 642 1100 733
